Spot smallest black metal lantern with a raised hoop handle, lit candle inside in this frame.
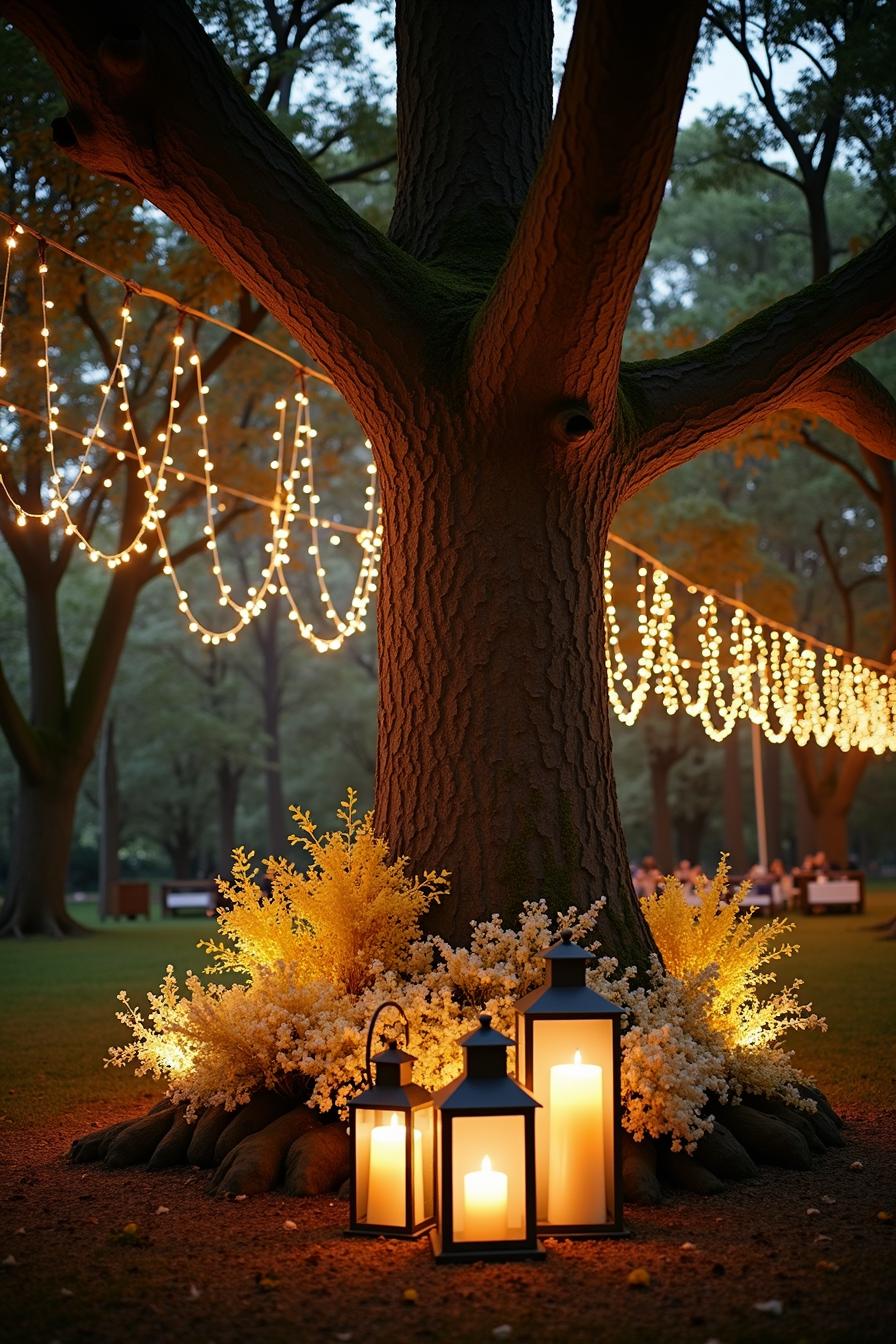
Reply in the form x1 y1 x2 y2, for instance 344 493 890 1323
348 1000 435 1238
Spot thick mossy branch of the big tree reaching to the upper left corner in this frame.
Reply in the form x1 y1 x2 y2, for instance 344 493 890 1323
0 0 435 415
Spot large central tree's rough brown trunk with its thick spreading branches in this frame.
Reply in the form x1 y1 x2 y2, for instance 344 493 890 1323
1 0 896 965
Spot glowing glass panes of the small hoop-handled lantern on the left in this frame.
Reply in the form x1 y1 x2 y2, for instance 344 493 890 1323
353 1106 433 1228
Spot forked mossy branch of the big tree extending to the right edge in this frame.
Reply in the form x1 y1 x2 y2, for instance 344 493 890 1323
623 230 896 493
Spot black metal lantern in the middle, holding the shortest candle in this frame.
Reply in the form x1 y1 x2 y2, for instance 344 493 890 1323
430 1013 544 1261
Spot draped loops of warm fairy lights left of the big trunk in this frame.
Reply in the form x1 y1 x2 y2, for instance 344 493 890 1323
0 222 383 653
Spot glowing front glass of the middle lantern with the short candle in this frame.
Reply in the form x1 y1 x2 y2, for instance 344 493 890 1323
451 1116 527 1242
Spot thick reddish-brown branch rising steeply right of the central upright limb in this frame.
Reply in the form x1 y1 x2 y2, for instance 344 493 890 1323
473 0 704 418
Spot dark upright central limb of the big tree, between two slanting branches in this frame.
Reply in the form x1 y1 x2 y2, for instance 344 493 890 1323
390 0 552 272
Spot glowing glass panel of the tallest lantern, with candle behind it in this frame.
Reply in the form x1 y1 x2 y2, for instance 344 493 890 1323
524 1017 615 1226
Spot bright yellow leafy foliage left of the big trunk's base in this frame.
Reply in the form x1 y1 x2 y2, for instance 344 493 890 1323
200 789 447 995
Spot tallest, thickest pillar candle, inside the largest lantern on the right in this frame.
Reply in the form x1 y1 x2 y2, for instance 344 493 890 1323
548 1050 607 1227
